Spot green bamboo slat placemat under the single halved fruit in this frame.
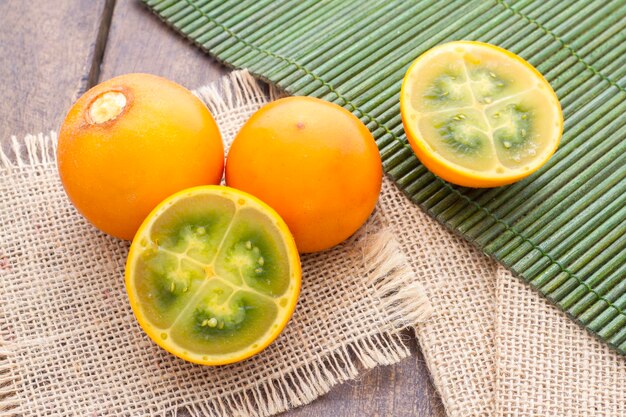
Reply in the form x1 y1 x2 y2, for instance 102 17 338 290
144 0 626 354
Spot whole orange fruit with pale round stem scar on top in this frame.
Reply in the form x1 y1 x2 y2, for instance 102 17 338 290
57 74 224 240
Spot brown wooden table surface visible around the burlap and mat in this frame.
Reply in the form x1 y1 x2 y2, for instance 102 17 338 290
0 0 445 417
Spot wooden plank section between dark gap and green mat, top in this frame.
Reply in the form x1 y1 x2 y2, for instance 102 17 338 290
100 0 228 89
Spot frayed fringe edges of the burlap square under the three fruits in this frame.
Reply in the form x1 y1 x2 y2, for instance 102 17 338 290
0 71 432 417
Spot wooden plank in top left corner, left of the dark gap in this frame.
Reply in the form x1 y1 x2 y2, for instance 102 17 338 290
0 0 113 143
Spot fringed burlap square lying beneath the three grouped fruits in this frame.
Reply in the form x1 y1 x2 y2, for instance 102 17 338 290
0 72 431 417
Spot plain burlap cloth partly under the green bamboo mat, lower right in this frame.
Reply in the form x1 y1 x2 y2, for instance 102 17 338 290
380 183 626 417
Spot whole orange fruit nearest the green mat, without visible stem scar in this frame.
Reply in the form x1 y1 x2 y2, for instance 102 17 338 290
226 97 382 252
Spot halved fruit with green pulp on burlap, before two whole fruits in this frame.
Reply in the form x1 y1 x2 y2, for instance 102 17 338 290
126 186 301 365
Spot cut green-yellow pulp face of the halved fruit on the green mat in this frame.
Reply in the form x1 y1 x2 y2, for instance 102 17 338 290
409 46 560 173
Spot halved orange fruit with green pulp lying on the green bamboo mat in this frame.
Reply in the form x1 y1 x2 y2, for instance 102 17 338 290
400 41 563 187
